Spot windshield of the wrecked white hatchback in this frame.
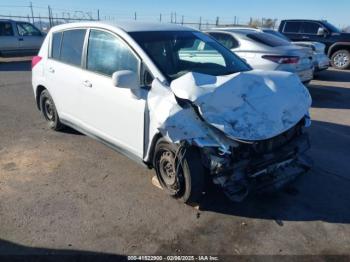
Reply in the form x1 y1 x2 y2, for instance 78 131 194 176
130 31 251 81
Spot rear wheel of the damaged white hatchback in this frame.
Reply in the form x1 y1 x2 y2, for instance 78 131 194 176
40 89 64 131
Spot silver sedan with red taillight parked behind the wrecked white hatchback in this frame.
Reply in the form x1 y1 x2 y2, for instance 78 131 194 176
206 28 314 83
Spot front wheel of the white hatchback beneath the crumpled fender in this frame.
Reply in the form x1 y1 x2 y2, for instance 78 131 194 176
153 138 206 204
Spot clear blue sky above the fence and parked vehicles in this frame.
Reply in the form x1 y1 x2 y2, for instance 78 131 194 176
0 0 350 27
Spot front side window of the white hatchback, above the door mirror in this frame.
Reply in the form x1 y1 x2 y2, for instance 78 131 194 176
86 30 139 76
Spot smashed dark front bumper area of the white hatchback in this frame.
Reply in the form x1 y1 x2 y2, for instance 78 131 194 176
213 133 312 202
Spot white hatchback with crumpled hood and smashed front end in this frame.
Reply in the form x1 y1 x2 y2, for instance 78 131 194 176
32 22 311 203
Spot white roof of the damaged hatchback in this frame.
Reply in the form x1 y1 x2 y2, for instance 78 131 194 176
49 21 195 32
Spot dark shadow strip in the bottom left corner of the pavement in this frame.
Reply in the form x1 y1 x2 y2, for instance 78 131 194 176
0 239 127 262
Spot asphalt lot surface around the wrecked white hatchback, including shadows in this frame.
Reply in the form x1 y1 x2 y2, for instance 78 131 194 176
0 59 350 255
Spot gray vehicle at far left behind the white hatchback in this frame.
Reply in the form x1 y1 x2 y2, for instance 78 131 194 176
0 19 45 56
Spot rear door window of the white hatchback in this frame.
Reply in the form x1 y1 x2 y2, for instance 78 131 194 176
59 29 86 66
